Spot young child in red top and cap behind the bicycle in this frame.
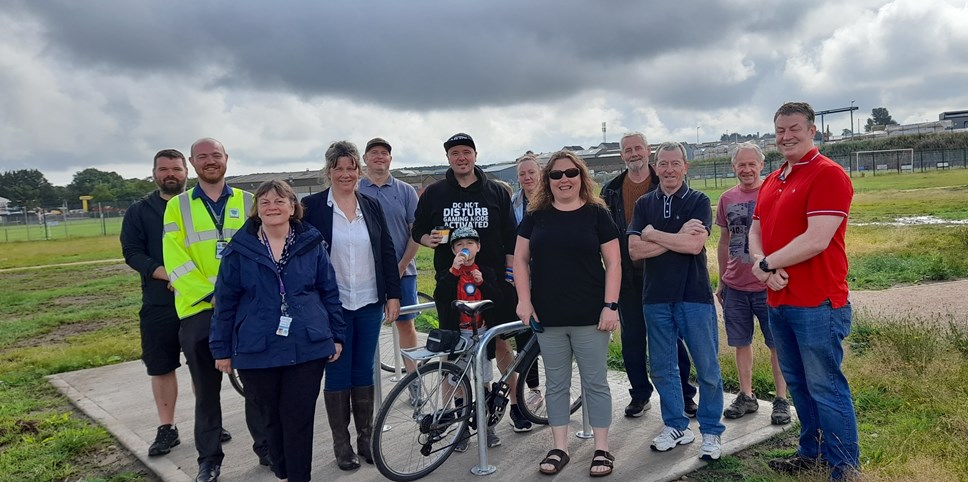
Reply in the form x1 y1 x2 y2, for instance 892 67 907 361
439 227 502 452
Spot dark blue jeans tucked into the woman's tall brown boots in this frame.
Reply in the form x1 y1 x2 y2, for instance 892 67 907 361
323 303 383 392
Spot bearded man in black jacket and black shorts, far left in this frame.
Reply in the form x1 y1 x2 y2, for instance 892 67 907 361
121 149 188 456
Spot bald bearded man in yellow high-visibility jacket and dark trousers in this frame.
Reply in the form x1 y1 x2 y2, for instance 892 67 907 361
162 138 271 482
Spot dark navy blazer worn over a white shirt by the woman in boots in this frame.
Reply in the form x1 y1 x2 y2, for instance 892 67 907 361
302 189 400 303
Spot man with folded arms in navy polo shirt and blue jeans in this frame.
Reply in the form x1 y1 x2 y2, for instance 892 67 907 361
628 142 726 460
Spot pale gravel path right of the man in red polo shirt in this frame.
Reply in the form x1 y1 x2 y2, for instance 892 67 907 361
850 280 968 320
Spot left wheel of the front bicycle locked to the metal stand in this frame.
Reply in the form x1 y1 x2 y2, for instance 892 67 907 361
373 362 472 481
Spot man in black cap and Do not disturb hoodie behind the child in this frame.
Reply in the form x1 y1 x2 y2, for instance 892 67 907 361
412 132 517 436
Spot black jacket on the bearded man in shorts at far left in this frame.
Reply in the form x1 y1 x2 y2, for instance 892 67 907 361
121 191 175 306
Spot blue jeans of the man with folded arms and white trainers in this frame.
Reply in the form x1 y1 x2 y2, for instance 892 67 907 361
642 302 726 435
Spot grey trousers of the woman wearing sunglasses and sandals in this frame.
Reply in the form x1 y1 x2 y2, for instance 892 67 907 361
536 325 612 428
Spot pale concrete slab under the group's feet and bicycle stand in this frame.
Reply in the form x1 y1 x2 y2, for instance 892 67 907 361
50 361 790 482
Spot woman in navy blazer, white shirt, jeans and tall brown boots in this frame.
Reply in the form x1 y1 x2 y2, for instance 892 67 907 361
303 141 400 470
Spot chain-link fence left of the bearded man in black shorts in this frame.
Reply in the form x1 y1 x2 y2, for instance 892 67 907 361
0 201 134 242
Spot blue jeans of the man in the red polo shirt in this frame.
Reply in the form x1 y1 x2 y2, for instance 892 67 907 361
770 301 860 476
